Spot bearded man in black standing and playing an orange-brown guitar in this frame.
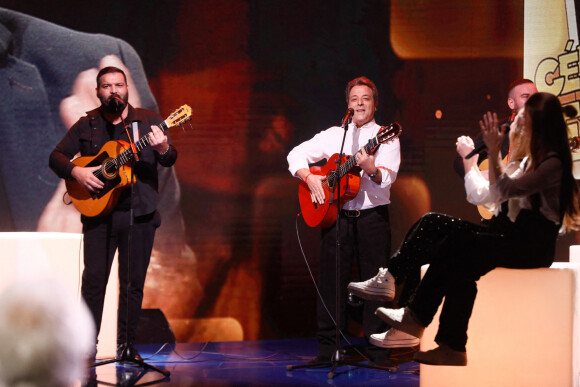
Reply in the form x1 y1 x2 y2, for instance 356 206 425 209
49 67 177 359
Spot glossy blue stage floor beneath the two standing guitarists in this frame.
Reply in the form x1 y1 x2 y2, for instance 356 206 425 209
88 339 419 387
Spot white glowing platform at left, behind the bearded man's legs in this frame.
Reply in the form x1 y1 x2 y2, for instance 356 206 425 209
0 232 119 359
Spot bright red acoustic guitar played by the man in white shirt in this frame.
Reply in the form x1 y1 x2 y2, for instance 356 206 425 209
298 122 402 228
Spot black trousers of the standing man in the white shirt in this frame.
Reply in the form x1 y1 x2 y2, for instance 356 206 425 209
316 205 391 358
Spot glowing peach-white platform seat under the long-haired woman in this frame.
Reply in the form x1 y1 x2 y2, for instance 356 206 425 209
420 260 580 387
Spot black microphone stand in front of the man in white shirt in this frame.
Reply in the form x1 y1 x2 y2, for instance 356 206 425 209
286 115 390 379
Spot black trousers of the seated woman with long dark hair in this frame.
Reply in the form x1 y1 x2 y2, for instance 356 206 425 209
402 210 558 351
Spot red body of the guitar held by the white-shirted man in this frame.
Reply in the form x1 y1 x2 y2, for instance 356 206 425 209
298 154 360 228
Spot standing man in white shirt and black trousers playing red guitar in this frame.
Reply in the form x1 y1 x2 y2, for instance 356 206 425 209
288 77 401 362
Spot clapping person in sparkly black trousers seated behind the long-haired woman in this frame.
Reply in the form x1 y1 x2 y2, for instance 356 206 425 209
349 102 575 354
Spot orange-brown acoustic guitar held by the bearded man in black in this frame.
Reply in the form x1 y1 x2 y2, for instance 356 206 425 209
65 105 191 217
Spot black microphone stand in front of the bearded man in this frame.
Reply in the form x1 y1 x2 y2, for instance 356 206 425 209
93 107 170 380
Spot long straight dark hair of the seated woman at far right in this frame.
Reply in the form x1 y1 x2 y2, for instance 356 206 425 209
525 93 579 226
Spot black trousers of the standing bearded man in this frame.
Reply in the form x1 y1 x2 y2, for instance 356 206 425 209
81 211 161 344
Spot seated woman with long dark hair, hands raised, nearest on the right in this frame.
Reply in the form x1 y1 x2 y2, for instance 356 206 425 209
368 93 579 366
